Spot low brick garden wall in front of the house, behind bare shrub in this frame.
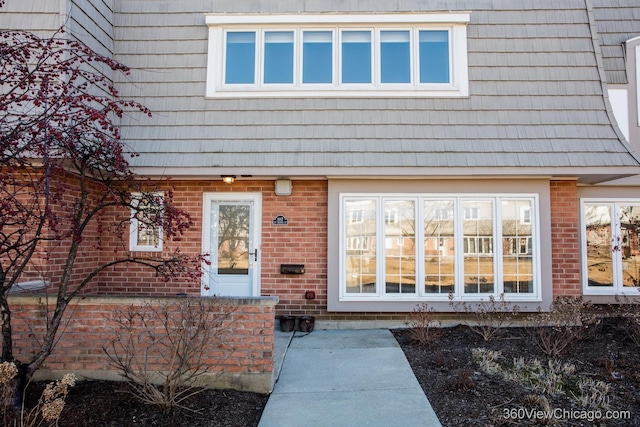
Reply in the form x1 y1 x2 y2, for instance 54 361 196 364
10 296 277 393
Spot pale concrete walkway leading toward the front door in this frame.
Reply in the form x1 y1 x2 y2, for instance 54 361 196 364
259 329 440 427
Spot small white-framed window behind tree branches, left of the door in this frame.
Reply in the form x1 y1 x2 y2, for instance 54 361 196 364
129 192 164 252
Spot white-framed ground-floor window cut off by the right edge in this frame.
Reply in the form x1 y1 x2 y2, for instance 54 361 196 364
581 199 640 295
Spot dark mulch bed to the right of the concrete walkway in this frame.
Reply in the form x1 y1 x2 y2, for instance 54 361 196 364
393 319 640 427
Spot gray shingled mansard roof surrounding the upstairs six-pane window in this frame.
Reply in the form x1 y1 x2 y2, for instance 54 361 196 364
109 0 640 181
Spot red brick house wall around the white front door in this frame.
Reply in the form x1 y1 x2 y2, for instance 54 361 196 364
93 180 327 314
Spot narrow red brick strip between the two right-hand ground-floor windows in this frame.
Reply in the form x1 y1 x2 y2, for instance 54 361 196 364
550 181 581 297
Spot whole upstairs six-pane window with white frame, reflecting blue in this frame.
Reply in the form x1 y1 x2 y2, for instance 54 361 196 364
206 13 469 97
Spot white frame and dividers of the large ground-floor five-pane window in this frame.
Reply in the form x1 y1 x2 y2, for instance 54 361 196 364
338 193 542 302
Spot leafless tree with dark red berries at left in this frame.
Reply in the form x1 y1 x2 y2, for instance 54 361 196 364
0 26 203 402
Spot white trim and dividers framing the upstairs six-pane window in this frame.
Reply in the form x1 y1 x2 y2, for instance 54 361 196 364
205 12 470 98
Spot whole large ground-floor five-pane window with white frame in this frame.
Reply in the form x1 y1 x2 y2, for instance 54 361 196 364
340 194 540 301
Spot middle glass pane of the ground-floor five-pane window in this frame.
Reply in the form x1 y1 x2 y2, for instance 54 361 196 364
424 200 455 293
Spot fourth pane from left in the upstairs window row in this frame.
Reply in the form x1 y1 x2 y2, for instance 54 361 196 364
341 31 371 83
